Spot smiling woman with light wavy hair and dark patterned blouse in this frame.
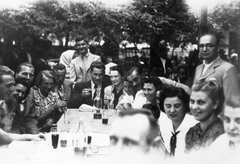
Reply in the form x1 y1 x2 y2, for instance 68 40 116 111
185 81 224 152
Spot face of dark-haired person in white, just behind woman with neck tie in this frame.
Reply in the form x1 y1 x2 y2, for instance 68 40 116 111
143 83 157 103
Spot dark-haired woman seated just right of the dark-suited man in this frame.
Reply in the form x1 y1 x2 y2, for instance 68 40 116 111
104 66 125 109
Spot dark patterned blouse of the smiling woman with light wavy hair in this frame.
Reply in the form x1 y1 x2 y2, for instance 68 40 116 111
185 118 224 153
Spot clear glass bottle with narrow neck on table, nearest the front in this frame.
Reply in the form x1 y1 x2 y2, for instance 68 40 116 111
73 119 87 157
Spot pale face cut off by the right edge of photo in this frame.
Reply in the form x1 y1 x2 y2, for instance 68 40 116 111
223 106 240 143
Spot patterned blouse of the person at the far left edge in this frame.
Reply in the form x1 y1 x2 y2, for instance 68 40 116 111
0 100 15 132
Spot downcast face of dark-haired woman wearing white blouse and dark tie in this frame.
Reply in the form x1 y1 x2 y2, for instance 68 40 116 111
163 97 186 122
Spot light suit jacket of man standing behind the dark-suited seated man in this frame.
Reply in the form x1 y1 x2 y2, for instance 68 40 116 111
70 53 101 82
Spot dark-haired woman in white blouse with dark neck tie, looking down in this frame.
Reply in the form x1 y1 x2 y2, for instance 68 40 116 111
159 86 196 156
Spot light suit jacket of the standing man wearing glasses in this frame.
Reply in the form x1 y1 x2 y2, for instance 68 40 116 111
193 58 240 100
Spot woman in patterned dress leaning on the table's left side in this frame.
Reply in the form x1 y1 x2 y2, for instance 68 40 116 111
26 70 67 132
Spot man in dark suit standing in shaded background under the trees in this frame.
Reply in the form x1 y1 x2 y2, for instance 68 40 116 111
149 40 172 77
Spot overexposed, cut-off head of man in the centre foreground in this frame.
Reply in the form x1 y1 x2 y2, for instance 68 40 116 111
109 109 167 161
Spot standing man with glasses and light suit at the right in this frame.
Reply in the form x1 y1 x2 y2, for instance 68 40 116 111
193 32 240 101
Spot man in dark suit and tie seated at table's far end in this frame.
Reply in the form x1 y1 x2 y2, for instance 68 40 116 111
68 61 109 108
